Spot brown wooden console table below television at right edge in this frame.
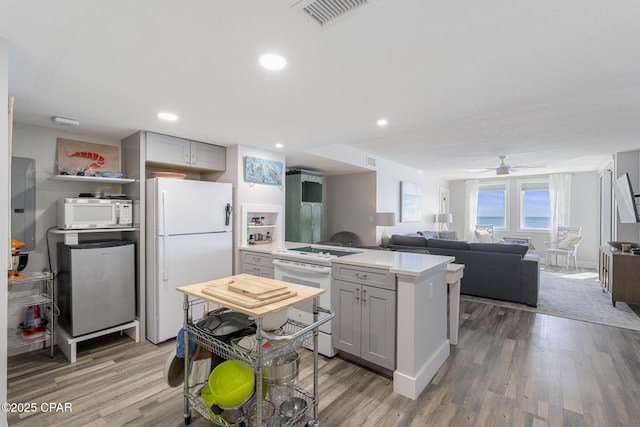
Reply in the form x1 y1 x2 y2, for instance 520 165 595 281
598 246 640 307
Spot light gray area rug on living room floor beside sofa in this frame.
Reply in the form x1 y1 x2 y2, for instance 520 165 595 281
460 269 640 330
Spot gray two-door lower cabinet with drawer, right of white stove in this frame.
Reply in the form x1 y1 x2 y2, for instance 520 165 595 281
331 264 396 370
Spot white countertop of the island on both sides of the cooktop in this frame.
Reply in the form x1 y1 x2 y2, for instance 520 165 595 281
239 242 455 276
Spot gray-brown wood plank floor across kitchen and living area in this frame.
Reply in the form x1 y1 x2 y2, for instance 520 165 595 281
8 301 640 427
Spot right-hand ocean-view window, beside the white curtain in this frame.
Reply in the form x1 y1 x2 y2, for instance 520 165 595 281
519 180 551 230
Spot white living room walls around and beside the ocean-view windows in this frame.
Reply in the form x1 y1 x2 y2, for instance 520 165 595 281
450 172 604 268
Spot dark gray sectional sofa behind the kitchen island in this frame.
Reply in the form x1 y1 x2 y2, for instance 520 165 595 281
389 234 540 307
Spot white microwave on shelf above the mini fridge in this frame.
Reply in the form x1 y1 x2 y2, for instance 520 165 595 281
58 198 133 230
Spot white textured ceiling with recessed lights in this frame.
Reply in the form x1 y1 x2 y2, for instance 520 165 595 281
0 0 640 179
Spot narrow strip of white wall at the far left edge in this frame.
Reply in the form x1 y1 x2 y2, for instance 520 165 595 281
0 37 11 426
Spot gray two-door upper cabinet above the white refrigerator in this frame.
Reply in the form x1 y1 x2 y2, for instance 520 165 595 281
146 132 226 171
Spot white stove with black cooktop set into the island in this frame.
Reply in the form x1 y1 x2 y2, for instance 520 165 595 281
271 245 364 357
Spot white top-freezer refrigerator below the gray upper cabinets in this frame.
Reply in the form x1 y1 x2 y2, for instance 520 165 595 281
146 178 233 344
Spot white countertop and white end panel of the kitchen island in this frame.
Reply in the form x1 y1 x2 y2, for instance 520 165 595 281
240 242 454 399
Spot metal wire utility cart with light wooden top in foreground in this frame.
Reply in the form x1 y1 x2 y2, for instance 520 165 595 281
176 274 334 427
